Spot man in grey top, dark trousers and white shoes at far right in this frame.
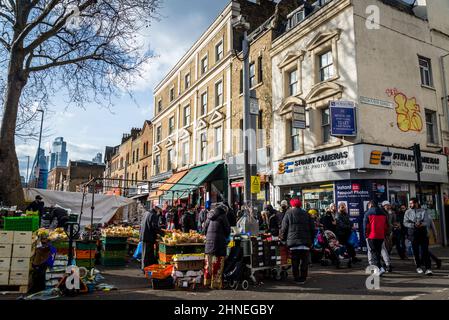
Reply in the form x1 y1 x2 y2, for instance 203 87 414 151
404 198 433 276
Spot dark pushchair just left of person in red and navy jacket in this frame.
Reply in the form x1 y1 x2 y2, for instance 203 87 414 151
321 230 352 269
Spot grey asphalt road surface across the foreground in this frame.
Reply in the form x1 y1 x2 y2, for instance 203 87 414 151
0 248 449 300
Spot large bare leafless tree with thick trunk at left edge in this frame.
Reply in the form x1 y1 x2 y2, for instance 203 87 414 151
0 0 161 205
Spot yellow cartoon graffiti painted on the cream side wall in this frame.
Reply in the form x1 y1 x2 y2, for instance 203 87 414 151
386 88 423 132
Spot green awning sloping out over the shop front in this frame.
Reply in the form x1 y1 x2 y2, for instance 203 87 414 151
162 161 224 200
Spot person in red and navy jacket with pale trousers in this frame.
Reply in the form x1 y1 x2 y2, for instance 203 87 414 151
363 200 390 276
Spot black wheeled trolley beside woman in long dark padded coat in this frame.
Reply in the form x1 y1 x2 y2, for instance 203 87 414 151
223 242 251 290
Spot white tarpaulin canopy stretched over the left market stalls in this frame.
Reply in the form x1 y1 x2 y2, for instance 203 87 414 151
24 188 135 226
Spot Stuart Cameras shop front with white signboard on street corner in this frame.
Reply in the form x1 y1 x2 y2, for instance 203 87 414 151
274 144 448 243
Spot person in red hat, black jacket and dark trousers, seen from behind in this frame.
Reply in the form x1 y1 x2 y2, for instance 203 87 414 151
280 198 315 284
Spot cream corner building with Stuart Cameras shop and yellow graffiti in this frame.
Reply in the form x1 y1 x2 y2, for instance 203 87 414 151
271 0 449 242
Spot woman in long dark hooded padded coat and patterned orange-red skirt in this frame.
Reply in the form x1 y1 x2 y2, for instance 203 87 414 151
204 204 231 289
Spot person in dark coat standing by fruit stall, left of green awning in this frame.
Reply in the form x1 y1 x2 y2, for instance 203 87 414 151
140 206 162 270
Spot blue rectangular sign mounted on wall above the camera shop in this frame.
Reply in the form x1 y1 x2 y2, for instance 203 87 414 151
329 101 357 136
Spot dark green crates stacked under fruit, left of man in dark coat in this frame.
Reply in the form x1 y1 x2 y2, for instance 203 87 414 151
101 237 128 267
